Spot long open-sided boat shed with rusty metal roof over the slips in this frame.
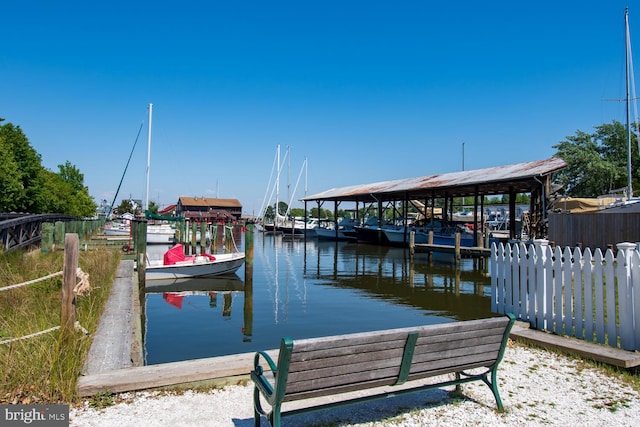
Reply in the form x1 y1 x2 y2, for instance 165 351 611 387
301 157 567 244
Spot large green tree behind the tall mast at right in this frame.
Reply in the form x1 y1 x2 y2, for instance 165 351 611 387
553 121 640 197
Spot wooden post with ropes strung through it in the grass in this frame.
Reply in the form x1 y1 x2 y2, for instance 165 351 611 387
0 234 90 344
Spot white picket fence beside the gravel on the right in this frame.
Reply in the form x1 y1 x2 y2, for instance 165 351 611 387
490 240 640 350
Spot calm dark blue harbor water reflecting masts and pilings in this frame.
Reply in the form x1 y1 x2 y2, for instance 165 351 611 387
144 230 491 364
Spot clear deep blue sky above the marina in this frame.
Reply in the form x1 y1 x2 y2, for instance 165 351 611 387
0 0 640 214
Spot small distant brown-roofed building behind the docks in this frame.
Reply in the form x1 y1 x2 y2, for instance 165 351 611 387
176 196 242 223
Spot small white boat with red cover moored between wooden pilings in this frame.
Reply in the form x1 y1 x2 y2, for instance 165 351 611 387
145 244 245 280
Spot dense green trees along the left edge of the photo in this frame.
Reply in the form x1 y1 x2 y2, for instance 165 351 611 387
0 119 97 217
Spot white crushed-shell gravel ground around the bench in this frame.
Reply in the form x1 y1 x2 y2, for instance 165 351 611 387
70 345 640 427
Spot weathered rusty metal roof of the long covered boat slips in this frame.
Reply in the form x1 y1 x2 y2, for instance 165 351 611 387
300 157 567 202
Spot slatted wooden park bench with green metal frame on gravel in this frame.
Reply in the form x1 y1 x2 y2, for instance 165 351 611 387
251 314 515 427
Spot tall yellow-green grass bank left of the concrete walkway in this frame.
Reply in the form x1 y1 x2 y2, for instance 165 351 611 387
0 249 120 404
